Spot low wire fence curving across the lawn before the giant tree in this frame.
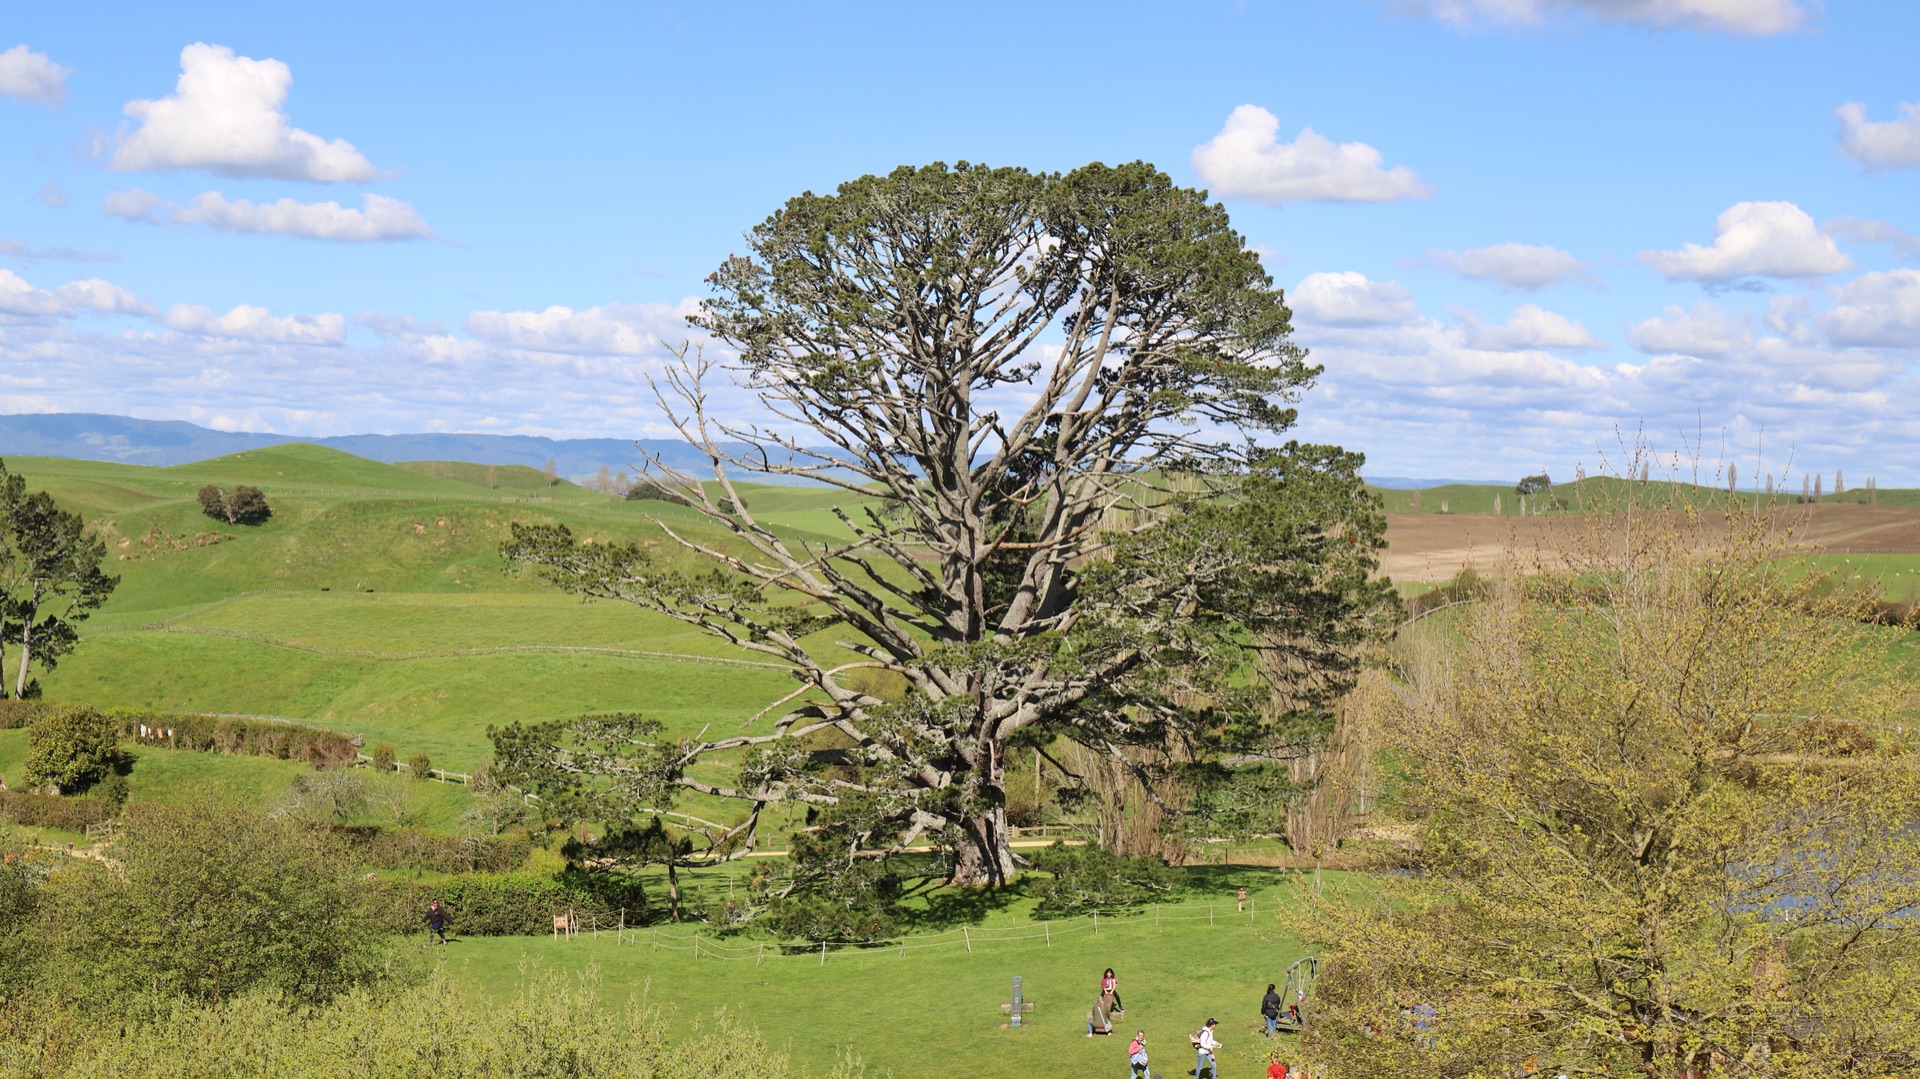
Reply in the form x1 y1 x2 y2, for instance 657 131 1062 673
555 899 1277 964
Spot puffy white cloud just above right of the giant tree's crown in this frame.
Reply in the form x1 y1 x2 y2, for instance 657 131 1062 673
1192 106 1432 204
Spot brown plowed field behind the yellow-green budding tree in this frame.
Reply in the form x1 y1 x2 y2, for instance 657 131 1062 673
1382 503 1920 580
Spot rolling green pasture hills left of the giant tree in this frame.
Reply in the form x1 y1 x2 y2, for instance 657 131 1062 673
8 445 871 791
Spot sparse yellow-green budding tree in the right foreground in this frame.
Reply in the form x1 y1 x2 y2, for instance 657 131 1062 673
1292 505 1920 1079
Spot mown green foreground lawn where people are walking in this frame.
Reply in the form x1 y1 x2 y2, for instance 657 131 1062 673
444 868 1338 1079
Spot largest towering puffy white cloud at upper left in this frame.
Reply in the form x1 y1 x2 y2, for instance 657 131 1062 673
109 44 376 182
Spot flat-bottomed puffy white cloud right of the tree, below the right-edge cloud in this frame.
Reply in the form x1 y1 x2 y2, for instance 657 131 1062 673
1640 202 1853 282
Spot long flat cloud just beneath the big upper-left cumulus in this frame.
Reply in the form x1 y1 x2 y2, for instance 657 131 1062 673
106 188 434 244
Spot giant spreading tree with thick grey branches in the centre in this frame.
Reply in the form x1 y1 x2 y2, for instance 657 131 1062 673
503 163 1392 883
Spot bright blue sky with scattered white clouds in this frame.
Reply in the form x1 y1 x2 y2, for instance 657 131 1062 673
0 0 1920 478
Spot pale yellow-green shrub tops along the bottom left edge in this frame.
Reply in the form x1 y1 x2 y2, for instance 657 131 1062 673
0 973 814 1079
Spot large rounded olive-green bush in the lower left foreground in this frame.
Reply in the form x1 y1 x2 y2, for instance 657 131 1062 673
44 803 382 1002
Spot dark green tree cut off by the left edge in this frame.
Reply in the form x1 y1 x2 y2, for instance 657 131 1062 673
0 463 119 697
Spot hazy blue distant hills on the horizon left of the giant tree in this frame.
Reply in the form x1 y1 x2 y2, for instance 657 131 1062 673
0 413 802 480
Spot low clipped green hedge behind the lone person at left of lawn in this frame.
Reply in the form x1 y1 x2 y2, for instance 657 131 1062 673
380 872 647 937
